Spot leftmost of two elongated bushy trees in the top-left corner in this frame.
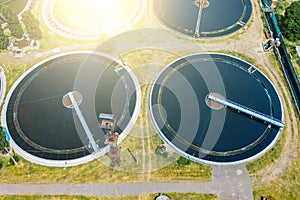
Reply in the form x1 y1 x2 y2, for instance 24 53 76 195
1 5 23 38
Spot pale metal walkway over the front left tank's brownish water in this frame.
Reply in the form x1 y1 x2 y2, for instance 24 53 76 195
68 92 99 152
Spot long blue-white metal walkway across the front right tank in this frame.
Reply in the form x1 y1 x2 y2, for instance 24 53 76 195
207 93 284 128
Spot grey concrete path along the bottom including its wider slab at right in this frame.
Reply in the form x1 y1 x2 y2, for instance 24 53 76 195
0 165 253 200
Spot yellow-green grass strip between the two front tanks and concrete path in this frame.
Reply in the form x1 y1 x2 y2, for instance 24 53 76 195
0 153 211 184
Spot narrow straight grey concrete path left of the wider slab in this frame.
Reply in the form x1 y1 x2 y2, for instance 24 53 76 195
0 183 211 196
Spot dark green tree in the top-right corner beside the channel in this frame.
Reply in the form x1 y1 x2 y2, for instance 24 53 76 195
279 1 300 42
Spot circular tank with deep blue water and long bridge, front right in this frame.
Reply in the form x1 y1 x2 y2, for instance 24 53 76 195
149 53 283 165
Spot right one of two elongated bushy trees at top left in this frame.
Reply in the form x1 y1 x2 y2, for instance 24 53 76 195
22 11 42 39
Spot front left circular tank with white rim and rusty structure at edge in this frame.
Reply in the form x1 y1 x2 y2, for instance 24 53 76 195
2 51 141 166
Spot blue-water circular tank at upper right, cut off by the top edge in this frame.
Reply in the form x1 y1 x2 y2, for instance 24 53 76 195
153 0 252 38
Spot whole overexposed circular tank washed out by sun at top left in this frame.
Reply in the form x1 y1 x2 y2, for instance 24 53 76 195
42 0 145 40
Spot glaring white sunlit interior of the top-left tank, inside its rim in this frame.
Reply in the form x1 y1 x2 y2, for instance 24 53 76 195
53 0 136 32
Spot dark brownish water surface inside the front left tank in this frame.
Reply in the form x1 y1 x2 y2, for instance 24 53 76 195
7 54 136 159
